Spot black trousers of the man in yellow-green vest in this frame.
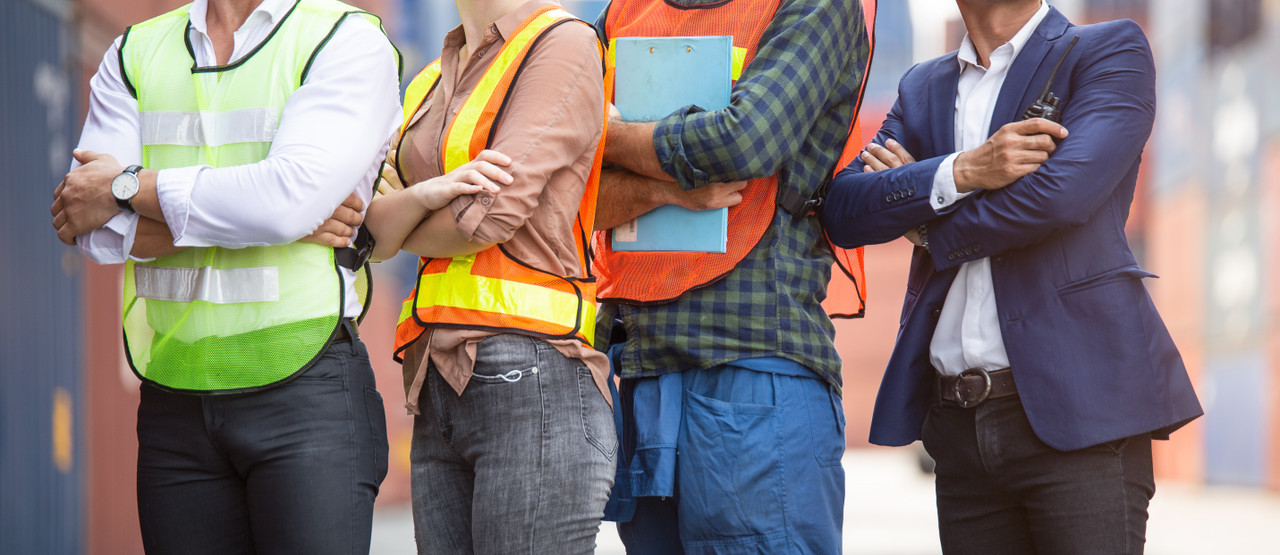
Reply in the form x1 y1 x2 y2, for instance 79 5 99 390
138 340 387 554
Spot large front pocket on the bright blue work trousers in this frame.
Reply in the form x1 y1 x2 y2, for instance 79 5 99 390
677 390 787 552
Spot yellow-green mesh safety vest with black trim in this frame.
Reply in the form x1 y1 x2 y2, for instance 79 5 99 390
120 0 399 393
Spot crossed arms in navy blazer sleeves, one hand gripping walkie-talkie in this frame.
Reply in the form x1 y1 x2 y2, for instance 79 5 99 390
824 22 1155 270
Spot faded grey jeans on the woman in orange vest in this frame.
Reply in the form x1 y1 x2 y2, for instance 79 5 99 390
410 334 617 554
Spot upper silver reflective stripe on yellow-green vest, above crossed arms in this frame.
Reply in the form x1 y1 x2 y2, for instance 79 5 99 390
142 107 280 147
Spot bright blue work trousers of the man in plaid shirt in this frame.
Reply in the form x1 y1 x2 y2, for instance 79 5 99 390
618 366 845 554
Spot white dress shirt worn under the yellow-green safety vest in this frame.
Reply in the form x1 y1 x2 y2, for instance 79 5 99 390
72 0 401 317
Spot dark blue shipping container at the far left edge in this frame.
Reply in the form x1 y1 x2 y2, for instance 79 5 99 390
0 0 86 554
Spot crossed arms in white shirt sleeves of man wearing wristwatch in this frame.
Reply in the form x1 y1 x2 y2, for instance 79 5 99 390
50 18 398 263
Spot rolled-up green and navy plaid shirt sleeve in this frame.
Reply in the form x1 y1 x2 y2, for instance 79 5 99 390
653 0 869 189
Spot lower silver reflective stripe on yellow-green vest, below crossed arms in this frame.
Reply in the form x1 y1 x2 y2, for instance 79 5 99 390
133 263 280 304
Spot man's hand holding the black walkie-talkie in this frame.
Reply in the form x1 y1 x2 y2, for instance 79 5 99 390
952 118 1066 193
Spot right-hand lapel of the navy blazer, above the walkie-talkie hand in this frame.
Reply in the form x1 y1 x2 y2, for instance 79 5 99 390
987 8 1068 137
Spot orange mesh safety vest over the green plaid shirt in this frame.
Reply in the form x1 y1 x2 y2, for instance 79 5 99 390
593 0 874 317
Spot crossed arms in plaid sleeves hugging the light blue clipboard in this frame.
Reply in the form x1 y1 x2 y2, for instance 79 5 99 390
595 0 865 230
